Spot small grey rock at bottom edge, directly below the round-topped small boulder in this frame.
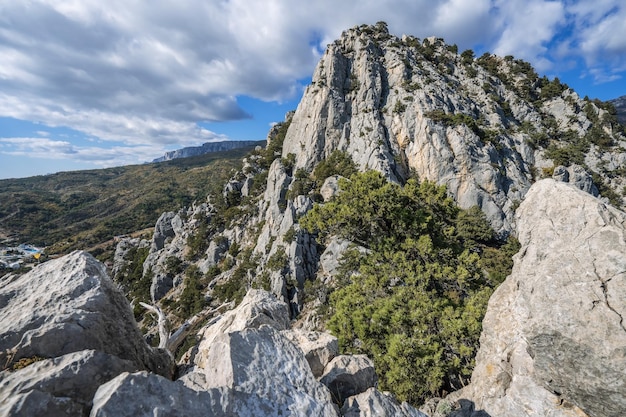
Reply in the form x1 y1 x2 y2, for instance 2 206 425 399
341 388 428 417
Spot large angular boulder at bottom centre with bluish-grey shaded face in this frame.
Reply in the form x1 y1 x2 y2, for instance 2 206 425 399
181 325 337 417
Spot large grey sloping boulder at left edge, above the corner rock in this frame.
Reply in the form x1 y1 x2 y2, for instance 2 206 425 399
0 251 173 376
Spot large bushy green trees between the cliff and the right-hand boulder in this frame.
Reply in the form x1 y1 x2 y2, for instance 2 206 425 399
300 171 518 404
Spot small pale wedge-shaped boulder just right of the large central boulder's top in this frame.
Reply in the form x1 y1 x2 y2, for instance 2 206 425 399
283 329 339 378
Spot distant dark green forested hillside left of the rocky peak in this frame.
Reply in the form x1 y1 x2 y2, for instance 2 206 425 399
0 147 258 254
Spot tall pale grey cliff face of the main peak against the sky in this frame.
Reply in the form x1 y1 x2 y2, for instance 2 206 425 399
282 24 624 233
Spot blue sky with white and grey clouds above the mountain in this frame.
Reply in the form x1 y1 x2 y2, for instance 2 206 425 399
0 0 626 179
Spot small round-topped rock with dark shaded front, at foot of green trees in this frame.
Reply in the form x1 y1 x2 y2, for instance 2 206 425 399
320 355 378 404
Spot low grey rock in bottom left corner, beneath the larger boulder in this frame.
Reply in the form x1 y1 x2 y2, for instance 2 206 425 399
0 350 137 416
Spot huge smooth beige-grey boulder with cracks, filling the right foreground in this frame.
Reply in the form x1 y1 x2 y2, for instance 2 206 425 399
450 180 626 417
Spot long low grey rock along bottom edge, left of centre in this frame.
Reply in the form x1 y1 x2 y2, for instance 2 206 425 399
90 372 276 417
